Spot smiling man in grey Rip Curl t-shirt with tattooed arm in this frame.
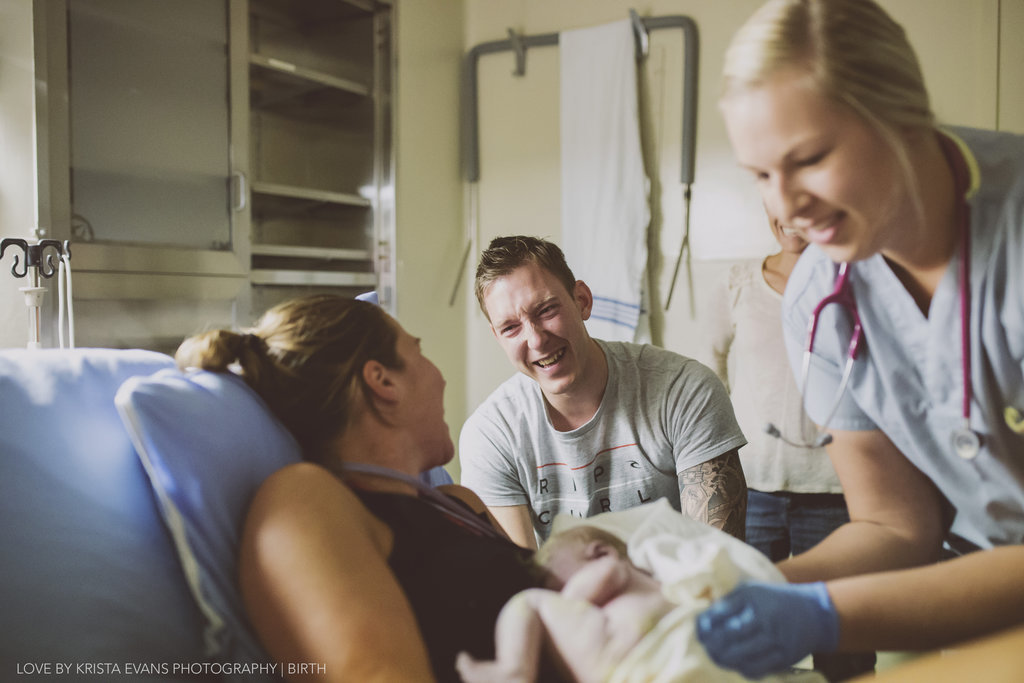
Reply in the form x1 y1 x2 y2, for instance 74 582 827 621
459 236 746 548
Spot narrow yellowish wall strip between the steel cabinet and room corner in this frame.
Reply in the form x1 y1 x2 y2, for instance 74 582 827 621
394 0 467 476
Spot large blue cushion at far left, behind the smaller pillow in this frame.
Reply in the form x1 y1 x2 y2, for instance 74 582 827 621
0 349 204 681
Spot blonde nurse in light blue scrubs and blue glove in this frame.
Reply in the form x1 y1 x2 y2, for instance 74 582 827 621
698 0 1024 677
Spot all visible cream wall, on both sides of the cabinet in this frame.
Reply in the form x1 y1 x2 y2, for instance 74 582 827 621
0 0 1024 458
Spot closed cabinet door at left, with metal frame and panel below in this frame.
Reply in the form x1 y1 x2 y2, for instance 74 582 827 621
34 0 250 351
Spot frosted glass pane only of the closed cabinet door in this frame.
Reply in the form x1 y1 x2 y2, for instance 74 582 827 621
68 0 231 249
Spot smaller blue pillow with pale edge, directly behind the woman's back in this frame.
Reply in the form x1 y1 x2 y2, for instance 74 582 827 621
116 370 300 680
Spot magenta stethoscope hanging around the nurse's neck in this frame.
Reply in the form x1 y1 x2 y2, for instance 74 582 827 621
764 136 981 460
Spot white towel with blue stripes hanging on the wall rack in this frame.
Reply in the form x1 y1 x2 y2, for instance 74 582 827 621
558 19 650 341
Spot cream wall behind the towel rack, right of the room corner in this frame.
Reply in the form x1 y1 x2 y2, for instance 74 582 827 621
466 0 1024 428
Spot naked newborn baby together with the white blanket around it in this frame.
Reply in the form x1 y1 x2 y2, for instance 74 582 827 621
457 501 824 683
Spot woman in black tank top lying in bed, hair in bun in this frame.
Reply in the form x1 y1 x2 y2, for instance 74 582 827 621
177 296 557 683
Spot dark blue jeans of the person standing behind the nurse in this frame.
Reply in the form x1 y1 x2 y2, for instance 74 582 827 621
746 488 876 683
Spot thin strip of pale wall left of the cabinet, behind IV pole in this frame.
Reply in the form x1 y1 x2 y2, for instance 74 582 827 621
0 0 36 347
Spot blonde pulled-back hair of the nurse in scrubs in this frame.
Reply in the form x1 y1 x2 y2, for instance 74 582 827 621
722 0 936 218
